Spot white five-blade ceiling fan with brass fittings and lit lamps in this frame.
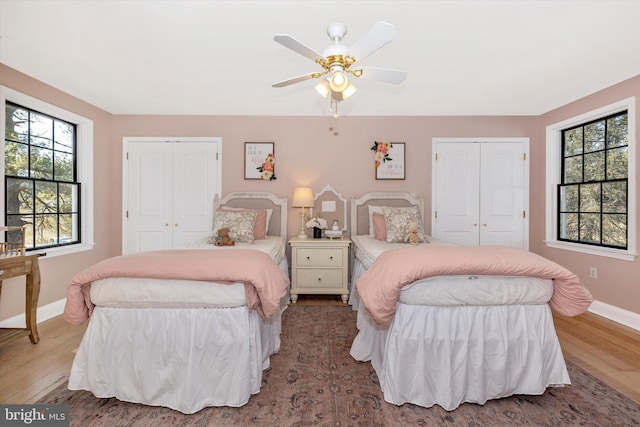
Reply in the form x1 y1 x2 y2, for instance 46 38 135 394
272 21 407 104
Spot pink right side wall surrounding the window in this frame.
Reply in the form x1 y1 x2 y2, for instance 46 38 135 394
530 76 640 313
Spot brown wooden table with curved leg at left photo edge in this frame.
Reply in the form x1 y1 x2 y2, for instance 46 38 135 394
0 254 44 345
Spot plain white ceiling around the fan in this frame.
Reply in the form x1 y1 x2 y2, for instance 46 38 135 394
0 0 640 116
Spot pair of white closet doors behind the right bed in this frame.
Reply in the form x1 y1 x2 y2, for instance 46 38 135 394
432 140 529 249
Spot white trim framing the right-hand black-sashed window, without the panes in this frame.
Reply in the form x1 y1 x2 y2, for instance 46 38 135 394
545 97 637 261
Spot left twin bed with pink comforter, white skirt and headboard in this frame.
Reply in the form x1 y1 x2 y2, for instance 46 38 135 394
65 192 289 414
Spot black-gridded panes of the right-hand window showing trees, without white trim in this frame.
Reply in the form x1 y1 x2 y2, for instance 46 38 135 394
558 111 629 249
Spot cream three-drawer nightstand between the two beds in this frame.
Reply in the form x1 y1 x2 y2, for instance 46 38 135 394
289 237 351 304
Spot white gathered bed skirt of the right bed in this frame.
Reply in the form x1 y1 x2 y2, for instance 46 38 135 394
351 292 571 411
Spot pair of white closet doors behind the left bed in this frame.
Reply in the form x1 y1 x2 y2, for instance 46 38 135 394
123 138 221 253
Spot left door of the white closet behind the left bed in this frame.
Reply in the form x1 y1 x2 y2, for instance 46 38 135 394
125 142 173 253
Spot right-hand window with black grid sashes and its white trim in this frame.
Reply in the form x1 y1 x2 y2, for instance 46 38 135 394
547 98 636 260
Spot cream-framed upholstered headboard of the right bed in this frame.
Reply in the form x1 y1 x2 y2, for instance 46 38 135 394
351 192 424 236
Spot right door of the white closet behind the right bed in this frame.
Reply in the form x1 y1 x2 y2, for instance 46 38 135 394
479 142 525 249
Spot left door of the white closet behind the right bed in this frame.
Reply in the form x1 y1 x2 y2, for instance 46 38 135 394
433 142 480 245
